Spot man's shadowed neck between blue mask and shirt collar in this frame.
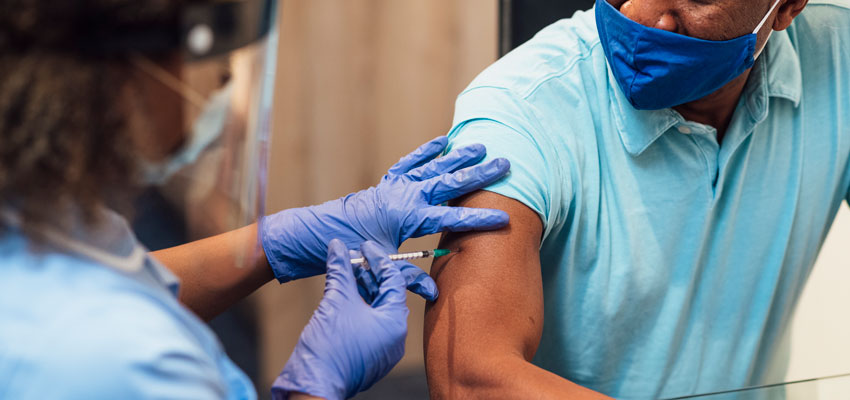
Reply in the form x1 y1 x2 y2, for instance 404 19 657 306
673 70 751 143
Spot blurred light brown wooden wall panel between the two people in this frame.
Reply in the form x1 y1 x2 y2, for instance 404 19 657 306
256 0 497 394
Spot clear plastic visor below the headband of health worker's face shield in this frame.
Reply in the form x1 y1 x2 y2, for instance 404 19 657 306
134 34 275 264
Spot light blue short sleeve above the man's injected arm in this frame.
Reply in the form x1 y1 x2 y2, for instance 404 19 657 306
449 87 572 237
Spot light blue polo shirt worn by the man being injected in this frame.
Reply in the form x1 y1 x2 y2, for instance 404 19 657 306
450 0 850 398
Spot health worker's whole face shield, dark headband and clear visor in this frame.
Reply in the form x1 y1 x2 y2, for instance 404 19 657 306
130 0 277 260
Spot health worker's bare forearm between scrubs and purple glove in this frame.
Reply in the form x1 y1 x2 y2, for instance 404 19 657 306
152 224 274 320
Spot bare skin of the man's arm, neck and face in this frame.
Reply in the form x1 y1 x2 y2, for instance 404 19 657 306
425 0 807 399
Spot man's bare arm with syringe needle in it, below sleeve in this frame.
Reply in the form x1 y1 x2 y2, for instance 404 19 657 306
425 192 607 399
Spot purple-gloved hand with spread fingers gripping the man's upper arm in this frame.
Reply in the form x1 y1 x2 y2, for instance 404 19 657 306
260 137 510 300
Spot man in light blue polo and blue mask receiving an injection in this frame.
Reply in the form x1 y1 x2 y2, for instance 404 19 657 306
425 0 850 398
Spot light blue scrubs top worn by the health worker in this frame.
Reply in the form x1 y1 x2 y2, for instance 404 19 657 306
0 213 256 399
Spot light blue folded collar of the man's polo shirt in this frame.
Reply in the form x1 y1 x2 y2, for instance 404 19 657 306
608 31 803 156
